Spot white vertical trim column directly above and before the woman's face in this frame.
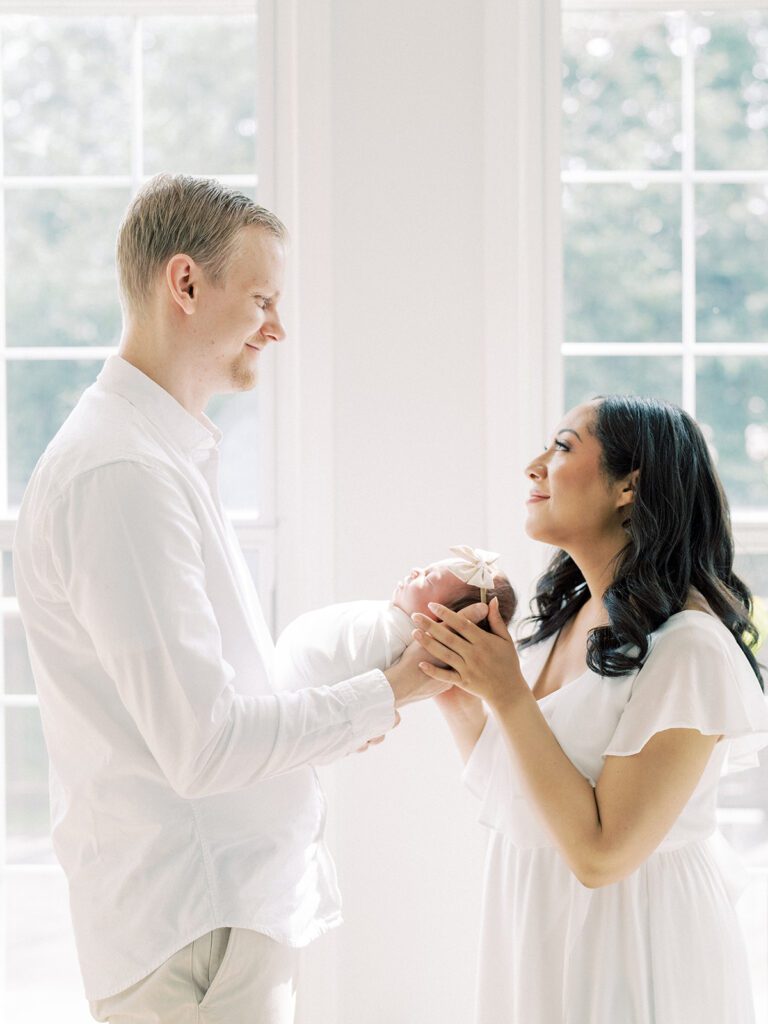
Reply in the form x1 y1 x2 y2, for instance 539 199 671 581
484 0 562 599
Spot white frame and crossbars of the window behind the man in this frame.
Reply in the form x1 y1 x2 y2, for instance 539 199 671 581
0 0 286 1007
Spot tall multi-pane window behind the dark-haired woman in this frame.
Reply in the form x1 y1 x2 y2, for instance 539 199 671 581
562 2 768 1020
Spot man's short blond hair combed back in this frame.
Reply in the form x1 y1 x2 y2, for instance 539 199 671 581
117 174 288 313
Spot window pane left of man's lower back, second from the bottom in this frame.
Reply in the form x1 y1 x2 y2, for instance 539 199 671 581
5 708 54 864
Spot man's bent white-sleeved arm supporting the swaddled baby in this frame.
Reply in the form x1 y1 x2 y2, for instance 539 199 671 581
49 462 409 797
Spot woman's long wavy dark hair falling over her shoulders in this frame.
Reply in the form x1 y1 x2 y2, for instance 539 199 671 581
519 395 764 688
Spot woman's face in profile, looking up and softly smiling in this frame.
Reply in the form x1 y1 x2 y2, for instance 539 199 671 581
525 402 632 554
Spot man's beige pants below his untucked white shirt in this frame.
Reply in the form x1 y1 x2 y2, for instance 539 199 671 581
90 928 298 1024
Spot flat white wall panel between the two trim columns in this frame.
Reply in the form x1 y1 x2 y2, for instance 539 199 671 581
323 0 486 1024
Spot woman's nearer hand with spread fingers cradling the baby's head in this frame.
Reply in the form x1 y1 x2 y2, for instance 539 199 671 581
412 598 530 707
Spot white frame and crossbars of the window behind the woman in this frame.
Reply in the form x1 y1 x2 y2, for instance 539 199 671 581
484 0 768 606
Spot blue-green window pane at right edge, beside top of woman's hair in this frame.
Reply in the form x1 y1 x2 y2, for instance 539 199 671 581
696 356 768 510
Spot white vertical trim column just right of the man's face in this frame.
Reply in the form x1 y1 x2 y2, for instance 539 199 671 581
272 0 334 630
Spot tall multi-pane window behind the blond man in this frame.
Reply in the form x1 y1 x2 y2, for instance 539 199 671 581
0 2 274 1024
